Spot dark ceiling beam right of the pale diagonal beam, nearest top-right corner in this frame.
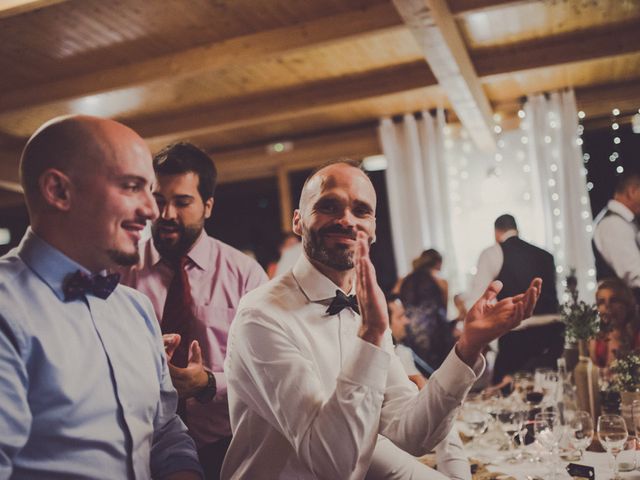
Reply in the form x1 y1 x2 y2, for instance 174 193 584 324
471 22 640 77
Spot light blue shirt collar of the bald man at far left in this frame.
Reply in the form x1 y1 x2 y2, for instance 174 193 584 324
18 227 91 300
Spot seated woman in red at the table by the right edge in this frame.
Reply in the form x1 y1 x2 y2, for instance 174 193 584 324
589 278 640 368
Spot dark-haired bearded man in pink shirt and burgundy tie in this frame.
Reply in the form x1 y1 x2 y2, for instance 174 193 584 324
123 143 267 479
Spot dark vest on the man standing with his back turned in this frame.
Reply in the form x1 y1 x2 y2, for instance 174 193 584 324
496 237 558 315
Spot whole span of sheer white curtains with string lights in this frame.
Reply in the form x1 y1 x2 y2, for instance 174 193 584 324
378 91 595 301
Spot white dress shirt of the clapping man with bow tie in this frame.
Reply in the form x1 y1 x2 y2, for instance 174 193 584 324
222 255 484 480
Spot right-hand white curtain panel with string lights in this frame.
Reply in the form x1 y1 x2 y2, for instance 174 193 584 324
522 90 596 301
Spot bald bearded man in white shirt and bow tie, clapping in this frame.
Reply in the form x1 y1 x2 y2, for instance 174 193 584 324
222 162 540 480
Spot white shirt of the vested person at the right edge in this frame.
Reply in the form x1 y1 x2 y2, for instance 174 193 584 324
593 200 640 287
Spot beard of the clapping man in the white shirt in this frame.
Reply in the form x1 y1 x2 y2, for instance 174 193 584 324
302 223 360 271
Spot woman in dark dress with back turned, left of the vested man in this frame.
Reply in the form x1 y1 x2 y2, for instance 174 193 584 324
398 249 458 368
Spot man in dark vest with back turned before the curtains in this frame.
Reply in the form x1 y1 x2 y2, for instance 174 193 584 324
464 214 564 383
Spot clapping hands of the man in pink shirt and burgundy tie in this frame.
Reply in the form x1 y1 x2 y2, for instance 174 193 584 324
162 333 208 398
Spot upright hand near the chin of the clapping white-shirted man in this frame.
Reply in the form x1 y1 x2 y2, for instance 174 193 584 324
354 232 389 346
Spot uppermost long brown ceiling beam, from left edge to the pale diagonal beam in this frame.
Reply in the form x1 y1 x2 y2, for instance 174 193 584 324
0 2 402 111
